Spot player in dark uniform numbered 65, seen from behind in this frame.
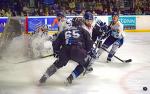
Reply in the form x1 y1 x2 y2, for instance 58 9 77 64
39 18 95 84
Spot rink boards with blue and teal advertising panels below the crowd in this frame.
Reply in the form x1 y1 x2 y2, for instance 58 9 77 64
0 15 150 33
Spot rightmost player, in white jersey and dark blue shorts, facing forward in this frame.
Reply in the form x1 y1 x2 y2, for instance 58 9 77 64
98 12 124 63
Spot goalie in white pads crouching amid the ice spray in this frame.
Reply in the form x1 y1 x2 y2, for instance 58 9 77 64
29 25 53 58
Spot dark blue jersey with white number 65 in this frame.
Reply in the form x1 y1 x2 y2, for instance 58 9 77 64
53 27 93 53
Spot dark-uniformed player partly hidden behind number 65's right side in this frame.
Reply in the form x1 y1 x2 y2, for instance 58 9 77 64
83 20 109 75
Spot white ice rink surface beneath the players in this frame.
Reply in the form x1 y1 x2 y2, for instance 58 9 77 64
0 33 150 94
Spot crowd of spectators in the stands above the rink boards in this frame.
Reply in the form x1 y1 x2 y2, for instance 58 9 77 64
0 0 150 17
